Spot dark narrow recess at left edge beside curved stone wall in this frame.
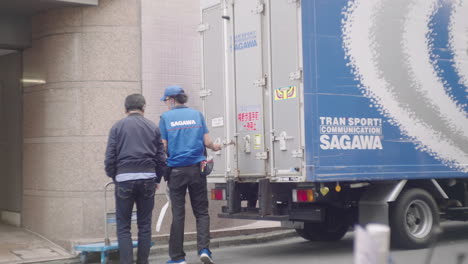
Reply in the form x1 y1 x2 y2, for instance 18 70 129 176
0 52 22 213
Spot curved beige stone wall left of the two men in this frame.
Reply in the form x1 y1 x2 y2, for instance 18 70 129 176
23 0 141 248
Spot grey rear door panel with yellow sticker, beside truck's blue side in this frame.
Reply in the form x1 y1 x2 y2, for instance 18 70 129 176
268 0 303 181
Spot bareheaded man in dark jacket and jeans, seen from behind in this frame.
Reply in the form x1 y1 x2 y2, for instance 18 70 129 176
104 94 166 264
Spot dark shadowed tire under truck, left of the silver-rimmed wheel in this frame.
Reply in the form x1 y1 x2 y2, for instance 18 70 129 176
296 210 349 242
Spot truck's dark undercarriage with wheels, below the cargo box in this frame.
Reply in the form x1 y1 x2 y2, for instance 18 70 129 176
216 179 468 248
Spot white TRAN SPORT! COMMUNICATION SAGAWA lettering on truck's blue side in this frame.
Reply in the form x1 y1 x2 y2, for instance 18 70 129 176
320 116 383 150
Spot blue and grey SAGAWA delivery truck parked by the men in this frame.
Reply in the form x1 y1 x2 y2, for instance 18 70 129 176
198 0 468 248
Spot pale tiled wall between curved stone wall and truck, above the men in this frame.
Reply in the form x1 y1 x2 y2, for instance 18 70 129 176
142 0 201 121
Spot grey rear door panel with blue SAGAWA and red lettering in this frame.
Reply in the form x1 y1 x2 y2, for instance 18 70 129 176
231 0 268 177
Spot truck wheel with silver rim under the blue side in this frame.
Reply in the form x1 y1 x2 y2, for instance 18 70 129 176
390 188 439 249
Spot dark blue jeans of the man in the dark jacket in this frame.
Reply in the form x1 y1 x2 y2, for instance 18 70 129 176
115 179 156 264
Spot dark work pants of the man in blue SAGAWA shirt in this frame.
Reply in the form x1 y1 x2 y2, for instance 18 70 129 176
169 164 210 261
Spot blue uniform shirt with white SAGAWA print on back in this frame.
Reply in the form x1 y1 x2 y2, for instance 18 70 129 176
159 106 208 167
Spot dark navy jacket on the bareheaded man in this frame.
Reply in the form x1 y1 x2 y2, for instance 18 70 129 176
104 113 166 183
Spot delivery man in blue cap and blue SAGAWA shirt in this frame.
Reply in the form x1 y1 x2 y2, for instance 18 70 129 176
159 86 221 264
